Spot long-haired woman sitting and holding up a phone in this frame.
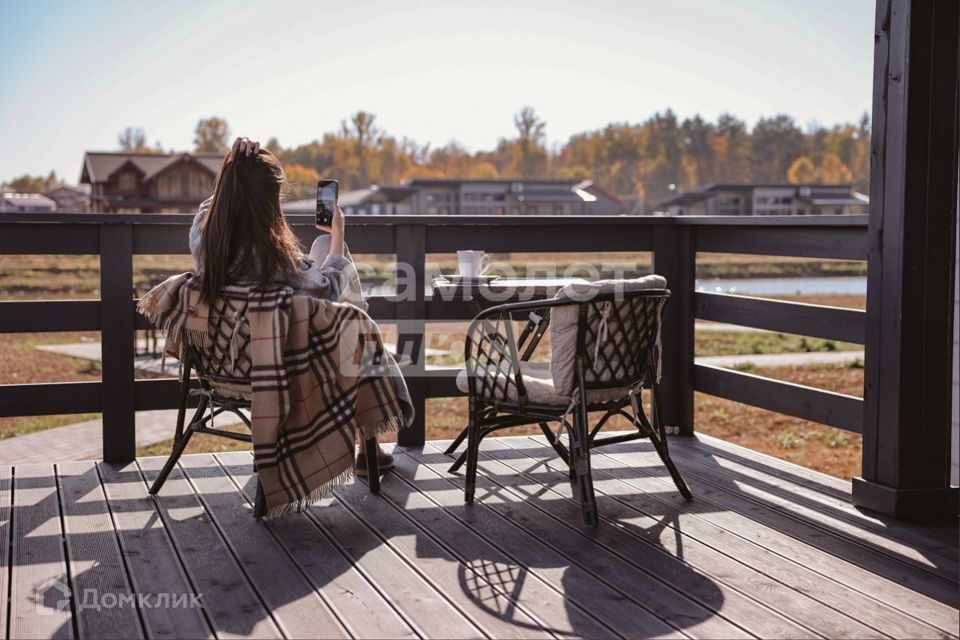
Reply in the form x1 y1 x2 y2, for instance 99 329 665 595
190 138 393 475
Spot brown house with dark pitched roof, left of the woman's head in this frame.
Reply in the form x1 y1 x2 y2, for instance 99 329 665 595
80 152 223 213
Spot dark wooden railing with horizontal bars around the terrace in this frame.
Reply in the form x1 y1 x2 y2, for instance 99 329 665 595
0 213 869 461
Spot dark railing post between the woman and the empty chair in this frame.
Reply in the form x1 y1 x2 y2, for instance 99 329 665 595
394 224 427 447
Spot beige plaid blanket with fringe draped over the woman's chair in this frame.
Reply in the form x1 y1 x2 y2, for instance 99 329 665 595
138 273 413 518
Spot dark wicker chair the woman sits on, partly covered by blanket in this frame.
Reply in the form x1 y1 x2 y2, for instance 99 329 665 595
150 298 380 518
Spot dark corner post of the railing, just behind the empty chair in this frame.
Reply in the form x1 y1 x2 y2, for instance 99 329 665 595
653 224 696 435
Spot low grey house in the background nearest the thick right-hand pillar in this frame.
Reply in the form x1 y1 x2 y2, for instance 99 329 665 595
657 183 870 216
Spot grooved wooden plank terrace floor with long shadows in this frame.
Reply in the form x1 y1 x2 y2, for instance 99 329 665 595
0 436 960 638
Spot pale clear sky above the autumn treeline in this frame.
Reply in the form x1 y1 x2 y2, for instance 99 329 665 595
0 0 874 182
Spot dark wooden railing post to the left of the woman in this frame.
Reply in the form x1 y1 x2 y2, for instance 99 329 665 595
100 223 137 462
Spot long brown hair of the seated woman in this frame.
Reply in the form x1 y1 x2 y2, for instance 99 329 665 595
201 149 301 300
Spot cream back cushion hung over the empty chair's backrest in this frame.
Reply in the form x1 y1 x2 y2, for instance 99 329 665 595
550 275 667 396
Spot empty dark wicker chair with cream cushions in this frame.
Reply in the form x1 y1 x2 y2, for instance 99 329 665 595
451 289 691 525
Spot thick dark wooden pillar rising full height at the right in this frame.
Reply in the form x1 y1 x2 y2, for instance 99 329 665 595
853 0 960 517
